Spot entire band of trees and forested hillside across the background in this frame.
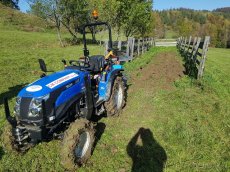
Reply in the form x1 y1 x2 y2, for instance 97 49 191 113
0 0 230 48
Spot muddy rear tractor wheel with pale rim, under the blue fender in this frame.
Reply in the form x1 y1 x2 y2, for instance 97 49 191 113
105 76 126 116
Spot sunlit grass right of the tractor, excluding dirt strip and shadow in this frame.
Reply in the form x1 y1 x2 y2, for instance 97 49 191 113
82 49 230 171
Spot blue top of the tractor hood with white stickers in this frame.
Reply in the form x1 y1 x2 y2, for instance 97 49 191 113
18 69 82 98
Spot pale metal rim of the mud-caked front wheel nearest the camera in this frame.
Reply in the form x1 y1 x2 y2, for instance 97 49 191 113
74 131 90 158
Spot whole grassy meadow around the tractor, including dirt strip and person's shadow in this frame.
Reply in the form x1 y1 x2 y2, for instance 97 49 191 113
0 5 230 172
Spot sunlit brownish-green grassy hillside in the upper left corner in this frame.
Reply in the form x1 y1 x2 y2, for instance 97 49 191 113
0 3 52 32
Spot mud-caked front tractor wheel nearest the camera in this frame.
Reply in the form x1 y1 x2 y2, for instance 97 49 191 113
60 119 94 171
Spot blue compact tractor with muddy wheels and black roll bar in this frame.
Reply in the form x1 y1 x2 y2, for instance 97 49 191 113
4 22 126 170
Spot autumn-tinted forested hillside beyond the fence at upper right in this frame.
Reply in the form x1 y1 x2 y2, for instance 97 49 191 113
153 7 230 48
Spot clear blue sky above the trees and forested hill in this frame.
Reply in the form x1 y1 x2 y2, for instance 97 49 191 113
19 0 230 12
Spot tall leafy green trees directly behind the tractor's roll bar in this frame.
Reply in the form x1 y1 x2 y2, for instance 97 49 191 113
28 0 153 44
